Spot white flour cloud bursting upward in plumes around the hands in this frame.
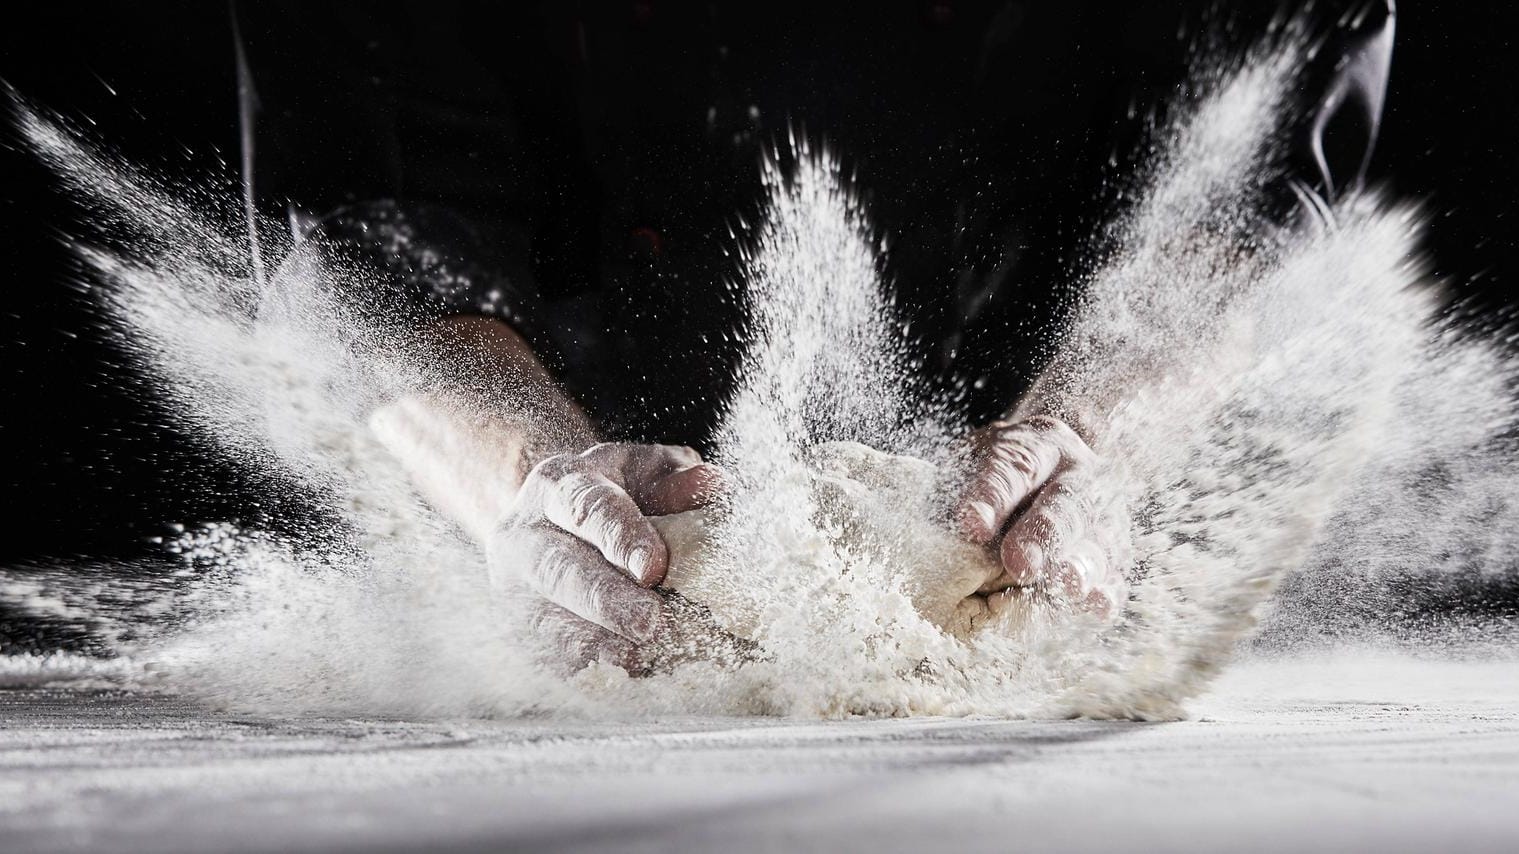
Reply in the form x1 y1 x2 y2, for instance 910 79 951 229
0 28 1519 717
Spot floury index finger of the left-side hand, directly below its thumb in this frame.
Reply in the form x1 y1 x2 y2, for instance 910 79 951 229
544 468 670 587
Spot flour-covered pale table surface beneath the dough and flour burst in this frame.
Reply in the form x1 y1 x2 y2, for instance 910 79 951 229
0 653 1519 852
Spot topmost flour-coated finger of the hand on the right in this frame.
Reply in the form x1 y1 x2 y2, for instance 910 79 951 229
958 418 1091 544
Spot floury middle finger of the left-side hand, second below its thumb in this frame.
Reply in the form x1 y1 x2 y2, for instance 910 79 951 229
523 530 664 643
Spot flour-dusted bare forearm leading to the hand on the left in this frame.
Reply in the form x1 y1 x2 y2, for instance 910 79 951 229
369 316 595 542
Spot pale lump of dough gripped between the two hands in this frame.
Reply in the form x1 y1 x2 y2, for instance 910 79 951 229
652 442 1001 640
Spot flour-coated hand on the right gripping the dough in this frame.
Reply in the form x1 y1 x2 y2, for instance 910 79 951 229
955 416 1130 617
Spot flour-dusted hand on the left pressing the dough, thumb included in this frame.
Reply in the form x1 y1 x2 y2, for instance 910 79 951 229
486 444 722 672
